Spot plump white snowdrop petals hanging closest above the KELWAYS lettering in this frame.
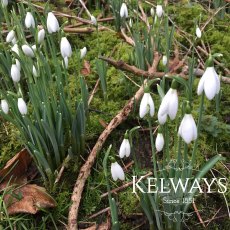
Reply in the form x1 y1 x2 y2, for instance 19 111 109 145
178 113 197 144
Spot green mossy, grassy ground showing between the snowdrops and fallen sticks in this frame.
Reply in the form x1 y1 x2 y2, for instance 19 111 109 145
0 1 230 230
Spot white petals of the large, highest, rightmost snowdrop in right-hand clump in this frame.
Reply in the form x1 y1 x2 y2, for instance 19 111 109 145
197 66 220 100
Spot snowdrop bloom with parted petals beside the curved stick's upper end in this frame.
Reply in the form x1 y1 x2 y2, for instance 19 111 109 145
139 87 155 118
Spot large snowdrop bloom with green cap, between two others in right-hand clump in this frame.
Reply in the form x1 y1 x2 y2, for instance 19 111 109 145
158 80 178 125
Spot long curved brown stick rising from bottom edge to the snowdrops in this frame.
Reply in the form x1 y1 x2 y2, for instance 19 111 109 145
68 81 144 230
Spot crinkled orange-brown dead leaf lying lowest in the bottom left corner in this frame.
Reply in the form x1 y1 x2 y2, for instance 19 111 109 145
4 184 56 215
